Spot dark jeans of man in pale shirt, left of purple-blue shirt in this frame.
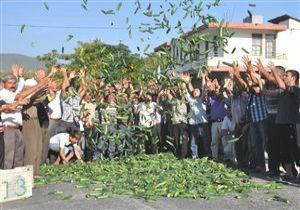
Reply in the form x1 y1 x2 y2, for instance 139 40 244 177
190 123 210 157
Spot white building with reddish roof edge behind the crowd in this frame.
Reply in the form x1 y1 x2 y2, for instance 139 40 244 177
155 15 300 72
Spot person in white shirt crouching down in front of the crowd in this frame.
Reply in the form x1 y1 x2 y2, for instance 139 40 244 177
49 128 83 165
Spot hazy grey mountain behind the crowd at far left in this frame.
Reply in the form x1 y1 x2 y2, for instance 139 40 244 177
0 53 45 71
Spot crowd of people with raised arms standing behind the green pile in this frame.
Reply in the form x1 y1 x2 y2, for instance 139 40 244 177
0 56 300 182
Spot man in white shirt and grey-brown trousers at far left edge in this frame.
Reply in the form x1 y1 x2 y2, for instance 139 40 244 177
0 75 48 169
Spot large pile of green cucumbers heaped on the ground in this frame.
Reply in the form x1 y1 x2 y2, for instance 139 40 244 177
35 154 280 199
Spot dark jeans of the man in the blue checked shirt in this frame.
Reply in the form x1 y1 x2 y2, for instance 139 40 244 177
248 120 267 168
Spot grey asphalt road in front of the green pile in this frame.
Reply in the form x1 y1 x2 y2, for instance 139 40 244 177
0 178 300 210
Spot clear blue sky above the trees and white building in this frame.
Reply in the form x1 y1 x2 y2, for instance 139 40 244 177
0 0 300 56
